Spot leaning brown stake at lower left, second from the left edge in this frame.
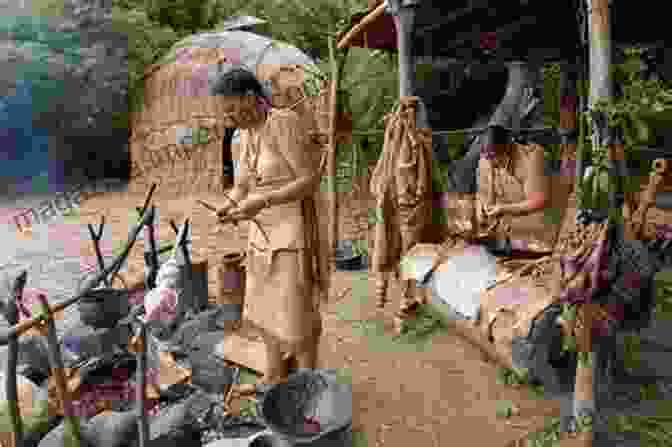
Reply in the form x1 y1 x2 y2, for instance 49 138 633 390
37 295 82 447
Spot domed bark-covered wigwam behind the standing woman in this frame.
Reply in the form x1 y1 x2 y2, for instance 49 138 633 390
129 31 324 199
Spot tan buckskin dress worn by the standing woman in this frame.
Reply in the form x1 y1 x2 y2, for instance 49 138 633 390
240 109 328 353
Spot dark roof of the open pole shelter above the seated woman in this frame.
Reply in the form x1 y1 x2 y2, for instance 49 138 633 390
342 0 666 61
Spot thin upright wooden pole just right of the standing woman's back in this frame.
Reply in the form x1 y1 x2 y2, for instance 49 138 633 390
328 37 339 268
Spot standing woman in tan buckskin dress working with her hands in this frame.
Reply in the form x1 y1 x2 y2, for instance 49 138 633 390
212 68 329 384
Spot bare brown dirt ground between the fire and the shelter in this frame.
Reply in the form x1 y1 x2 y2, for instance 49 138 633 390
80 189 560 447
